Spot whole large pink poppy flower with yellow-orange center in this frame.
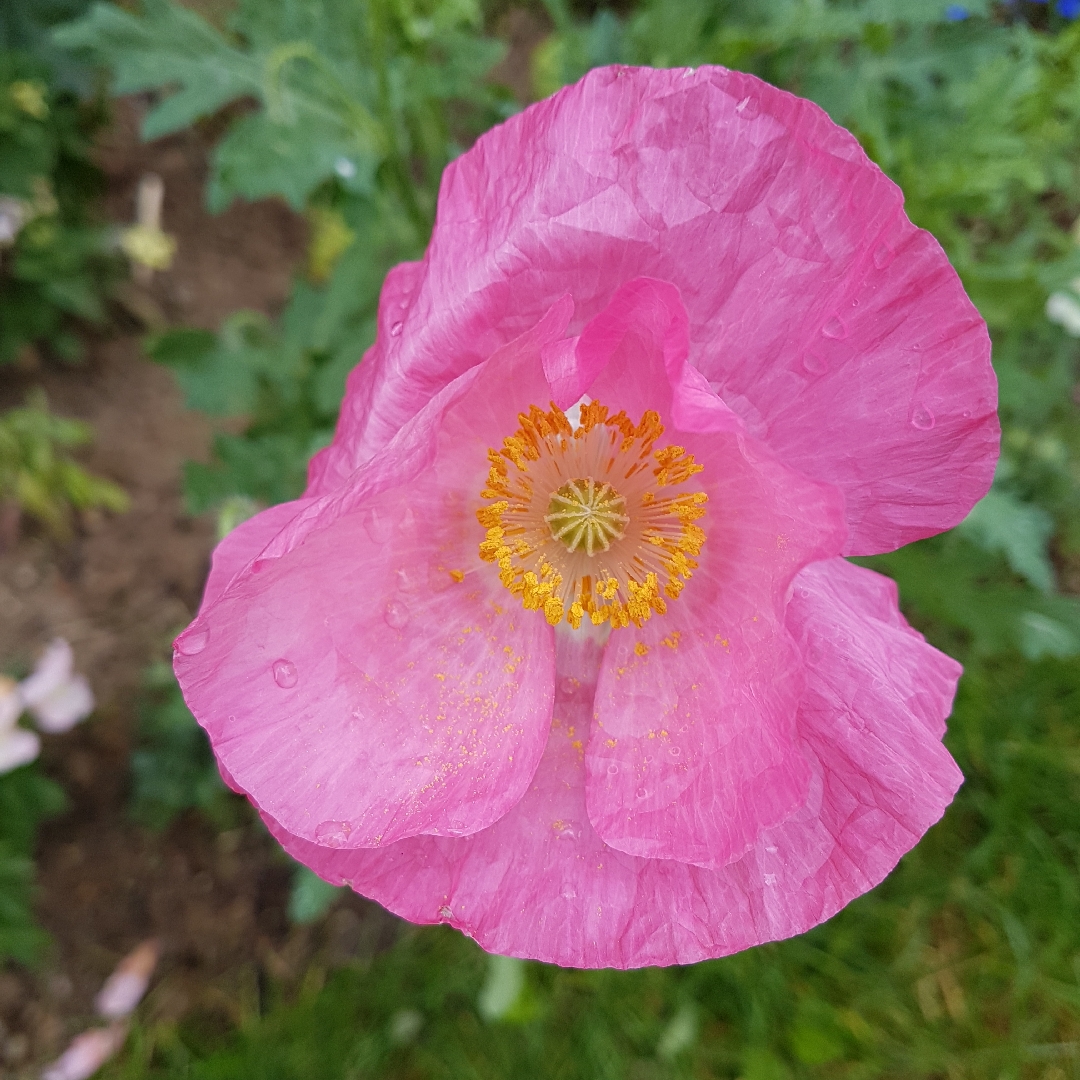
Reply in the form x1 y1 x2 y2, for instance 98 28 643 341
176 67 998 967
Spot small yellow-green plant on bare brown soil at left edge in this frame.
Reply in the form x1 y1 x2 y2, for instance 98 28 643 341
0 390 130 538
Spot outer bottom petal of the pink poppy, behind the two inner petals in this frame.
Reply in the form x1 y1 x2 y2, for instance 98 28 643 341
267 583 961 968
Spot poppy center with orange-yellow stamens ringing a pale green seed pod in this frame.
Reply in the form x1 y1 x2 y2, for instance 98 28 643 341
476 402 707 630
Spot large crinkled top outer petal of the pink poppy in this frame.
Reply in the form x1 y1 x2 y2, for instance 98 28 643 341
313 66 998 554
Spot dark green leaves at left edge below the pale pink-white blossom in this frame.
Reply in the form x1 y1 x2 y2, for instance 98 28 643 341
0 762 67 963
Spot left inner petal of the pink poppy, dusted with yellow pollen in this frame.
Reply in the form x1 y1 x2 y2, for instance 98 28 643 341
176 298 570 847
